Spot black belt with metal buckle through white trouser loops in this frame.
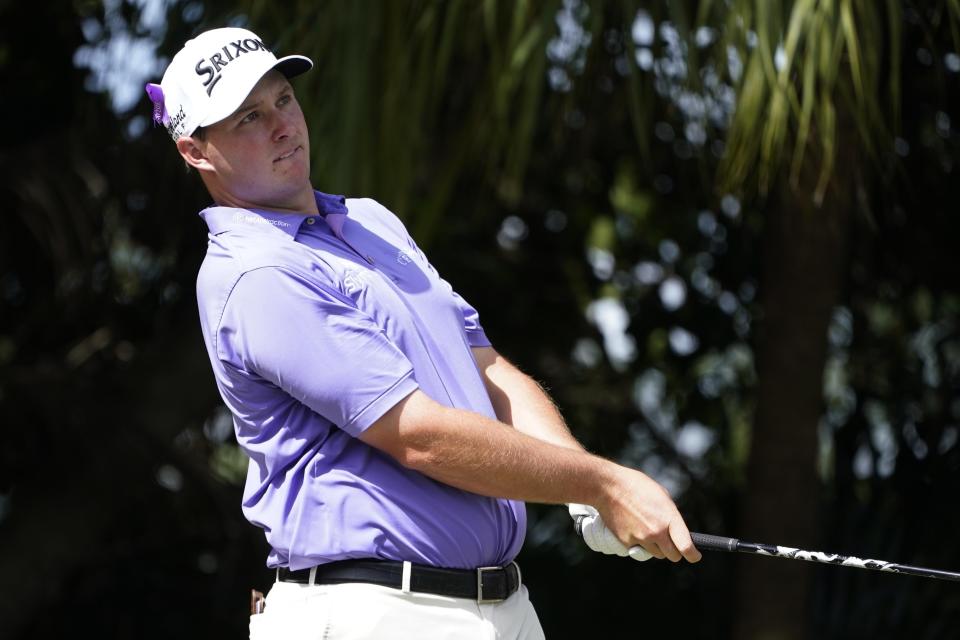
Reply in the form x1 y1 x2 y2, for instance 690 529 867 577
277 560 520 603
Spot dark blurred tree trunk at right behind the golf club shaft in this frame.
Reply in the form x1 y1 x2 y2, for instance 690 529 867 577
734 166 854 640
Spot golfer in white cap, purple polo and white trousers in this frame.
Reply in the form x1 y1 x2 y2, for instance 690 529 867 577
147 28 700 639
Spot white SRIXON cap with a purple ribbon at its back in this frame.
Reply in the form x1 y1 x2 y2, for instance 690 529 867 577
146 27 313 140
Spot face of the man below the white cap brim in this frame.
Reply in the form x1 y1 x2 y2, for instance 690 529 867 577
195 70 313 211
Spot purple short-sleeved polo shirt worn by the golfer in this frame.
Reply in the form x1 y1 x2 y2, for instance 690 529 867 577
197 192 526 569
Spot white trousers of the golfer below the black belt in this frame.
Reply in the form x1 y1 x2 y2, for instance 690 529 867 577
250 582 544 640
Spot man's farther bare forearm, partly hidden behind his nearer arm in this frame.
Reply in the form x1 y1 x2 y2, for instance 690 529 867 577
473 347 583 450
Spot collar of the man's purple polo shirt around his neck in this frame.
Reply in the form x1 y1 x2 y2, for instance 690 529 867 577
200 191 348 238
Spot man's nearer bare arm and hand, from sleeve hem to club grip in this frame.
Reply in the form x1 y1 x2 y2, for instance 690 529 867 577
360 390 700 562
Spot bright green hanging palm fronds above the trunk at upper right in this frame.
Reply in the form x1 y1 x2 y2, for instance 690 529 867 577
699 0 902 205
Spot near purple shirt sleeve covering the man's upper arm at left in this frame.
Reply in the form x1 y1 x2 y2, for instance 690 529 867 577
217 267 418 436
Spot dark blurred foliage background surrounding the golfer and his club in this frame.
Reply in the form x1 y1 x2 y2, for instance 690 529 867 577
0 0 960 639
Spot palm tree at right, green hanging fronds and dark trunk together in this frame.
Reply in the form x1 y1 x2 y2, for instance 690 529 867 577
656 0 960 639
